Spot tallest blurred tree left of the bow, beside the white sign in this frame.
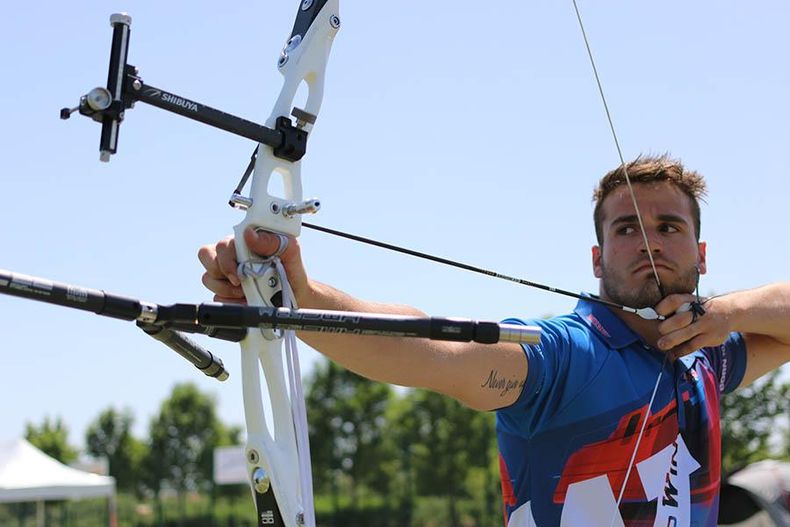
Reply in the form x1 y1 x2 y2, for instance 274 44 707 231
144 383 227 518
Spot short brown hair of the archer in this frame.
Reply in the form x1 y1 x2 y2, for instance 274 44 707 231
593 154 707 245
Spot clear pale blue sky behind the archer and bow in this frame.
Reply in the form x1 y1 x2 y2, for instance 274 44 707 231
0 0 790 445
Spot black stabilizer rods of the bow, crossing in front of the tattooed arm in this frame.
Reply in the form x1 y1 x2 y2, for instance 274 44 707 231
0 269 540 350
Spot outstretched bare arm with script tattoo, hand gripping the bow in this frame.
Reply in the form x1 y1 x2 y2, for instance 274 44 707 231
198 229 527 410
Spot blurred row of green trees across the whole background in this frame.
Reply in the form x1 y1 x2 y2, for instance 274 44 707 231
13 361 790 527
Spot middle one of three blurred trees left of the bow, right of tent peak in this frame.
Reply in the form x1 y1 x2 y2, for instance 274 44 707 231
85 408 145 492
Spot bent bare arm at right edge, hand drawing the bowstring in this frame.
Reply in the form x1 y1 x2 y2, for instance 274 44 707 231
657 283 790 386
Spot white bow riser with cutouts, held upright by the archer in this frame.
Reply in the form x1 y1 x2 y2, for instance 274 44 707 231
234 0 340 527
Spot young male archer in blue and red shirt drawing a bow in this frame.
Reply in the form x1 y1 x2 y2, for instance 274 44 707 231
199 156 790 527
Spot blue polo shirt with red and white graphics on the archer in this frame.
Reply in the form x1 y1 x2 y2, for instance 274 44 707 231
496 300 746 527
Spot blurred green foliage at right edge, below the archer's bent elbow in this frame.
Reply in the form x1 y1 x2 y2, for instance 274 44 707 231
721 370 790 474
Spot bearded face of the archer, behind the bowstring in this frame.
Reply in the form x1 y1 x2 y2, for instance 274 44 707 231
592 181 706 308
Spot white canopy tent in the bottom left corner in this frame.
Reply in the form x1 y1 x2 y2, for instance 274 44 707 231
0 439 115 522
